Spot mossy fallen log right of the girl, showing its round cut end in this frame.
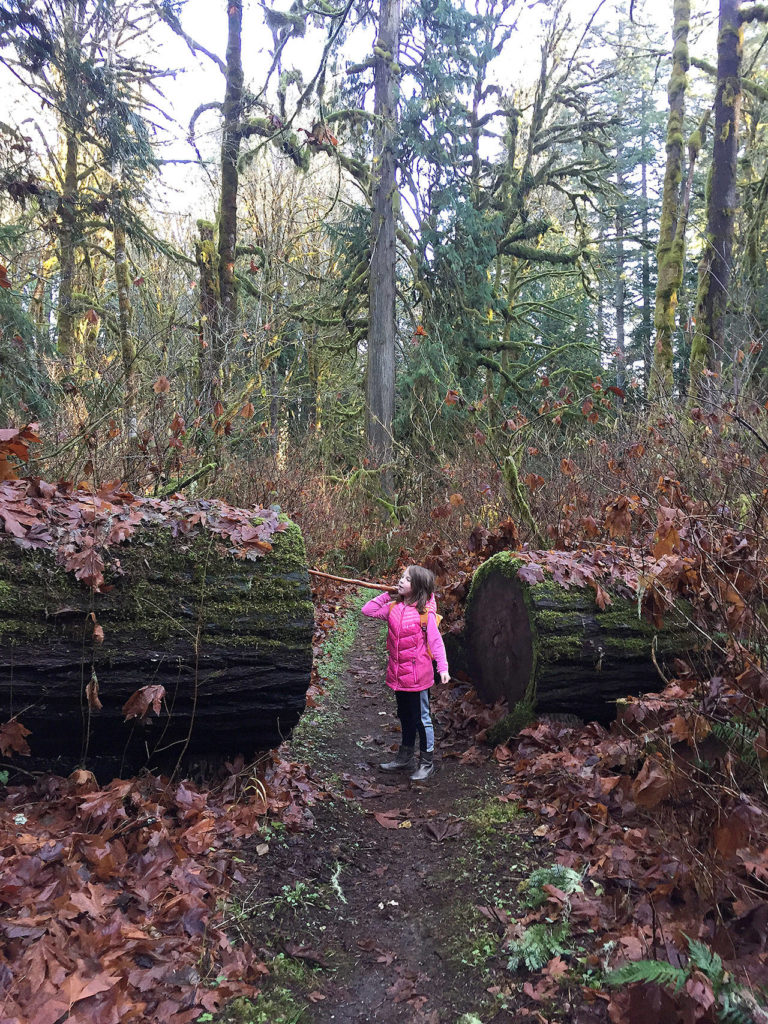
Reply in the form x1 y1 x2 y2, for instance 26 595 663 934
464 552 698 720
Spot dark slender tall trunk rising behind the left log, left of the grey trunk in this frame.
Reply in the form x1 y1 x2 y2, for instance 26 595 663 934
213 0 243 380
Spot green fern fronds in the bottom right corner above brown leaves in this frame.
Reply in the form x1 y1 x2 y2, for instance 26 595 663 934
605 936 765 1024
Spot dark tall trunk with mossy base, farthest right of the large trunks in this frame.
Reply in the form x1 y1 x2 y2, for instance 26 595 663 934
688 0 741 401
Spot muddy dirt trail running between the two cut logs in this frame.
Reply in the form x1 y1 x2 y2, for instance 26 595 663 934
227 620 549 1024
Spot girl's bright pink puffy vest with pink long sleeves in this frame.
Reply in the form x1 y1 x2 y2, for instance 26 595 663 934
360 593 447 690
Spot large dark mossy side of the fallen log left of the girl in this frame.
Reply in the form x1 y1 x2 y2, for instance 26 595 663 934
0 503 312 767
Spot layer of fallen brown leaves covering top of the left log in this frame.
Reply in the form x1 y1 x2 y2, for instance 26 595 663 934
0 478 287 593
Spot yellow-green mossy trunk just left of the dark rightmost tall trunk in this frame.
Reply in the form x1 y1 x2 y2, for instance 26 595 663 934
650 0 690 399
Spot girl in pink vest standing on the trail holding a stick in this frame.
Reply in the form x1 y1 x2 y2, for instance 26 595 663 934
360 565 451 782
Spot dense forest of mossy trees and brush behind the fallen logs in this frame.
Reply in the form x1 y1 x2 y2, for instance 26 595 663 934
0 0 768 568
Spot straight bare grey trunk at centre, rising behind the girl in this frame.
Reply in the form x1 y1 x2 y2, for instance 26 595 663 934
366 0 400 493
